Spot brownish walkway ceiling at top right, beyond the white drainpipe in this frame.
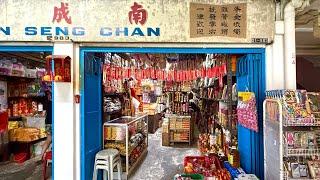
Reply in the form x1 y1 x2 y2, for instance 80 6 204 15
296 0 320 55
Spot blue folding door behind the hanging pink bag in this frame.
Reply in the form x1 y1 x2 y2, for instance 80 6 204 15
237 53 265 179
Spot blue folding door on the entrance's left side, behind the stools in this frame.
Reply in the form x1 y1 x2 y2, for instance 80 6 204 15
80 51 103 180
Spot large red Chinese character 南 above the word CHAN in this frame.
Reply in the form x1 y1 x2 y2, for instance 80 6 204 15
129 2 148 25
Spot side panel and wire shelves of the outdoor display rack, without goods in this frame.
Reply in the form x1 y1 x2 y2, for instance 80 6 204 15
263 99 320 180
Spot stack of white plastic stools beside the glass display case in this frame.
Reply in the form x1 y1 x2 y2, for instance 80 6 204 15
92 149 122 180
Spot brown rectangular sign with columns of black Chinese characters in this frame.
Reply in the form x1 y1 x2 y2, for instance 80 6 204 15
190 3 247 38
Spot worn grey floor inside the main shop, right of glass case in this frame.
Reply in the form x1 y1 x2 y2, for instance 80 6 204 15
129 129 199 180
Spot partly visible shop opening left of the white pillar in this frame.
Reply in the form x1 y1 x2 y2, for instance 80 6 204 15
0 46 54 179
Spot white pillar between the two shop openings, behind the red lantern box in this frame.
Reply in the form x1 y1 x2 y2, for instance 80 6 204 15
53 43 76 180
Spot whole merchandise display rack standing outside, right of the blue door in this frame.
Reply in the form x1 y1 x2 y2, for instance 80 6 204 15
264 90 320 179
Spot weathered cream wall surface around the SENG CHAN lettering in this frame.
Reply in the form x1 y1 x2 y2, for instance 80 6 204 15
0 0 275 43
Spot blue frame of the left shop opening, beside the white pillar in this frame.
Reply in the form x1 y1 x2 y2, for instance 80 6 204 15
0 45 54 179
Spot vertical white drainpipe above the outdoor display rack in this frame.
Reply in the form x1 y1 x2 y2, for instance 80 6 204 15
284 2 297 89
